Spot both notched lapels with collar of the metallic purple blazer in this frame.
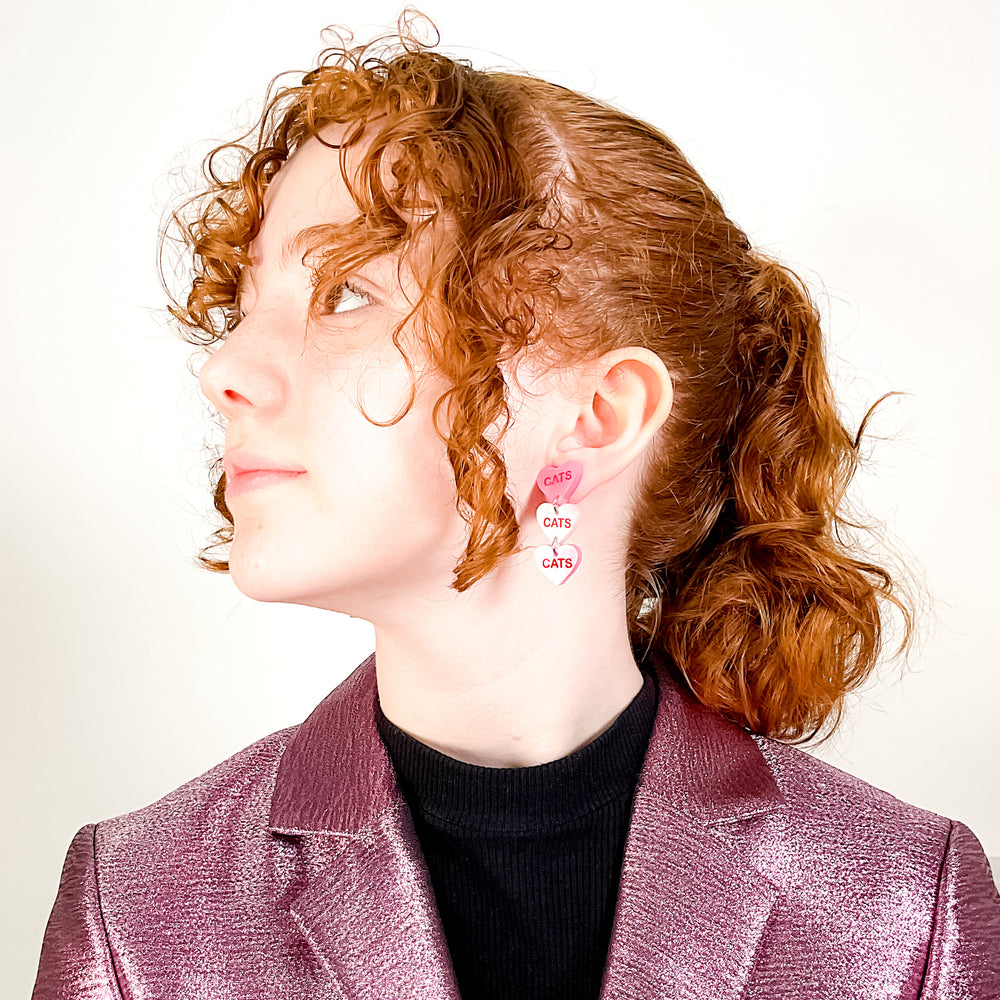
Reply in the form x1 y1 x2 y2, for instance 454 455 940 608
270 654 784 1000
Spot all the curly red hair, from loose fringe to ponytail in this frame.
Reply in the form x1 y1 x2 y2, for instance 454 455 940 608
166 19 911 741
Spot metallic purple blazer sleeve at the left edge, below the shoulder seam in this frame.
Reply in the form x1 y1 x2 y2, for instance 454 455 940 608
31 823 122 1000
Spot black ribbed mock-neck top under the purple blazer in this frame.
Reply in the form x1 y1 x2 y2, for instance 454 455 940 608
376 674 657 1000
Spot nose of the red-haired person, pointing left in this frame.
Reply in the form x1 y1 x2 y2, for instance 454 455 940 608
198 321 288 420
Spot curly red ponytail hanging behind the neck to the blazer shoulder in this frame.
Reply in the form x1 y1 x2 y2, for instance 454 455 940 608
636 253 911 742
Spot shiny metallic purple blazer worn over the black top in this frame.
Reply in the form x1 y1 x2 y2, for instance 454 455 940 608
33 654 1000 1000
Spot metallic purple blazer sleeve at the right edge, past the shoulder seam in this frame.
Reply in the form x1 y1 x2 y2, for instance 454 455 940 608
920 822 1000 1000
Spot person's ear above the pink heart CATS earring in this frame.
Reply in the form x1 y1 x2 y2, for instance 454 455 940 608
555 347 673 500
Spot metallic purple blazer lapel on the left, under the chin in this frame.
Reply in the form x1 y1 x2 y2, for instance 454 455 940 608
270 656 459 1000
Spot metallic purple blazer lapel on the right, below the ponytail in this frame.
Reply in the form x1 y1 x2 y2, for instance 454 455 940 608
601 674 784 1000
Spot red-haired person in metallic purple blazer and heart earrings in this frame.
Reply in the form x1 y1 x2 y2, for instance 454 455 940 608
34 17 1000 1000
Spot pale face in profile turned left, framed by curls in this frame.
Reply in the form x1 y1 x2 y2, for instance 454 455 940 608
201 131 480 619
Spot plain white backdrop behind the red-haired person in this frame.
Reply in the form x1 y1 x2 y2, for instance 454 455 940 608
0 0 1000 997
